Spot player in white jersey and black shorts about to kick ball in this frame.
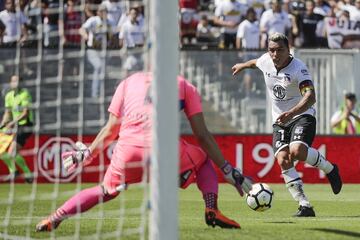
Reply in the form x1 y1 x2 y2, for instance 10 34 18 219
232 33 342 217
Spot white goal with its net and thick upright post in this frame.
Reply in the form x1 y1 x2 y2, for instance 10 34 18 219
0 0 178 239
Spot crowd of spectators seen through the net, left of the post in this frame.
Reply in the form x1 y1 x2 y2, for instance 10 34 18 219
0 0 145 49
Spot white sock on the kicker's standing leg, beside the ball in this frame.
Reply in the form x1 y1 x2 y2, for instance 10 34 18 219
281 167 311 207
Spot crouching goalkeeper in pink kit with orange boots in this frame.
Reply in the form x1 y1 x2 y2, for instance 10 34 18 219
36 73 251 231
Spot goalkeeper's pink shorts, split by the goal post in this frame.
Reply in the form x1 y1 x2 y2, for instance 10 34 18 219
103 142 207 195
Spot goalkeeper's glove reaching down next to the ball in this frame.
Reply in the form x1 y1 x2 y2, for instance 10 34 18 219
221 161 252 196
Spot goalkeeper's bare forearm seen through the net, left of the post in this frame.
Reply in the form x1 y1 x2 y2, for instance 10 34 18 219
89 113 120 157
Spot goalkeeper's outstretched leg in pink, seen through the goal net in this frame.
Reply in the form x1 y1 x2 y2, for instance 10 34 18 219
36 144 145 232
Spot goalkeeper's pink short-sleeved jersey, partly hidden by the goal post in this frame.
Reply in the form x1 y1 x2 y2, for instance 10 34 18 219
108 72 202 148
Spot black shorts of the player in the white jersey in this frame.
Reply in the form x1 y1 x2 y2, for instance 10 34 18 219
273 114 316 156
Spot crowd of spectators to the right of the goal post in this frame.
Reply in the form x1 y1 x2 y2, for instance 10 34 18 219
180 0 360 49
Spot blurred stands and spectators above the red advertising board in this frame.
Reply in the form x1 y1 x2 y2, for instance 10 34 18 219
0 0 360 133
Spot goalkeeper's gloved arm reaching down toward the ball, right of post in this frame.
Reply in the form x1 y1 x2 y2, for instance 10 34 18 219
189 113 252 196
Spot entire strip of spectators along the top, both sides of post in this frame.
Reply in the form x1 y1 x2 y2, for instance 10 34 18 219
0 0 360 49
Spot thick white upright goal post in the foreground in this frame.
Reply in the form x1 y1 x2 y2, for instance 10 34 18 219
149 0 179 240
